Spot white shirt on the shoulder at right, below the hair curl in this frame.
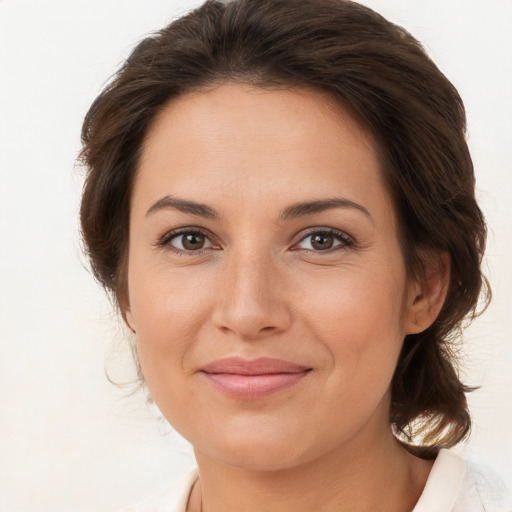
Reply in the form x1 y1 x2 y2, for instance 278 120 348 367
413 450 512 512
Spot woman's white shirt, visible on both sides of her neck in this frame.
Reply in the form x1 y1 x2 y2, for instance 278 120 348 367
123 450 512 512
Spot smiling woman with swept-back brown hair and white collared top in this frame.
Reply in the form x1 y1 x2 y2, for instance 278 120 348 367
81 0 508 512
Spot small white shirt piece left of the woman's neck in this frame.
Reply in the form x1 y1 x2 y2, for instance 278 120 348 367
122 468 198 512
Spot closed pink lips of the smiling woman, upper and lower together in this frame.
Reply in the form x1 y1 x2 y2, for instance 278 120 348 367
201 357 311 400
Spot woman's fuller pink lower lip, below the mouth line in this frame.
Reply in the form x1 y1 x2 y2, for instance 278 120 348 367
203 370 309 400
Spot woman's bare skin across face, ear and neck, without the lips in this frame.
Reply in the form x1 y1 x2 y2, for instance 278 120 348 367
125 84 448 512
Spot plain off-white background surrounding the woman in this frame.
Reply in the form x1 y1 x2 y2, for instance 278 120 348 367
0 0 512 512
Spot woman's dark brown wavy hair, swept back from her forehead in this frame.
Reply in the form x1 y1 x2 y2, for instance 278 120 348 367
81 0 489 457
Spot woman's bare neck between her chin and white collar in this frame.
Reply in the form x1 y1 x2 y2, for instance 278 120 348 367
188 432 432 512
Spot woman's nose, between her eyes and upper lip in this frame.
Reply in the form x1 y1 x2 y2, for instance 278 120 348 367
213 248 291 340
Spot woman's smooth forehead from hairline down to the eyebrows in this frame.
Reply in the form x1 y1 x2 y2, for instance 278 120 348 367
134 84 387 220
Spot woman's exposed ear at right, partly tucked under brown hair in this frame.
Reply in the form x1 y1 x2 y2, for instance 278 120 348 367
405 253 450 334
